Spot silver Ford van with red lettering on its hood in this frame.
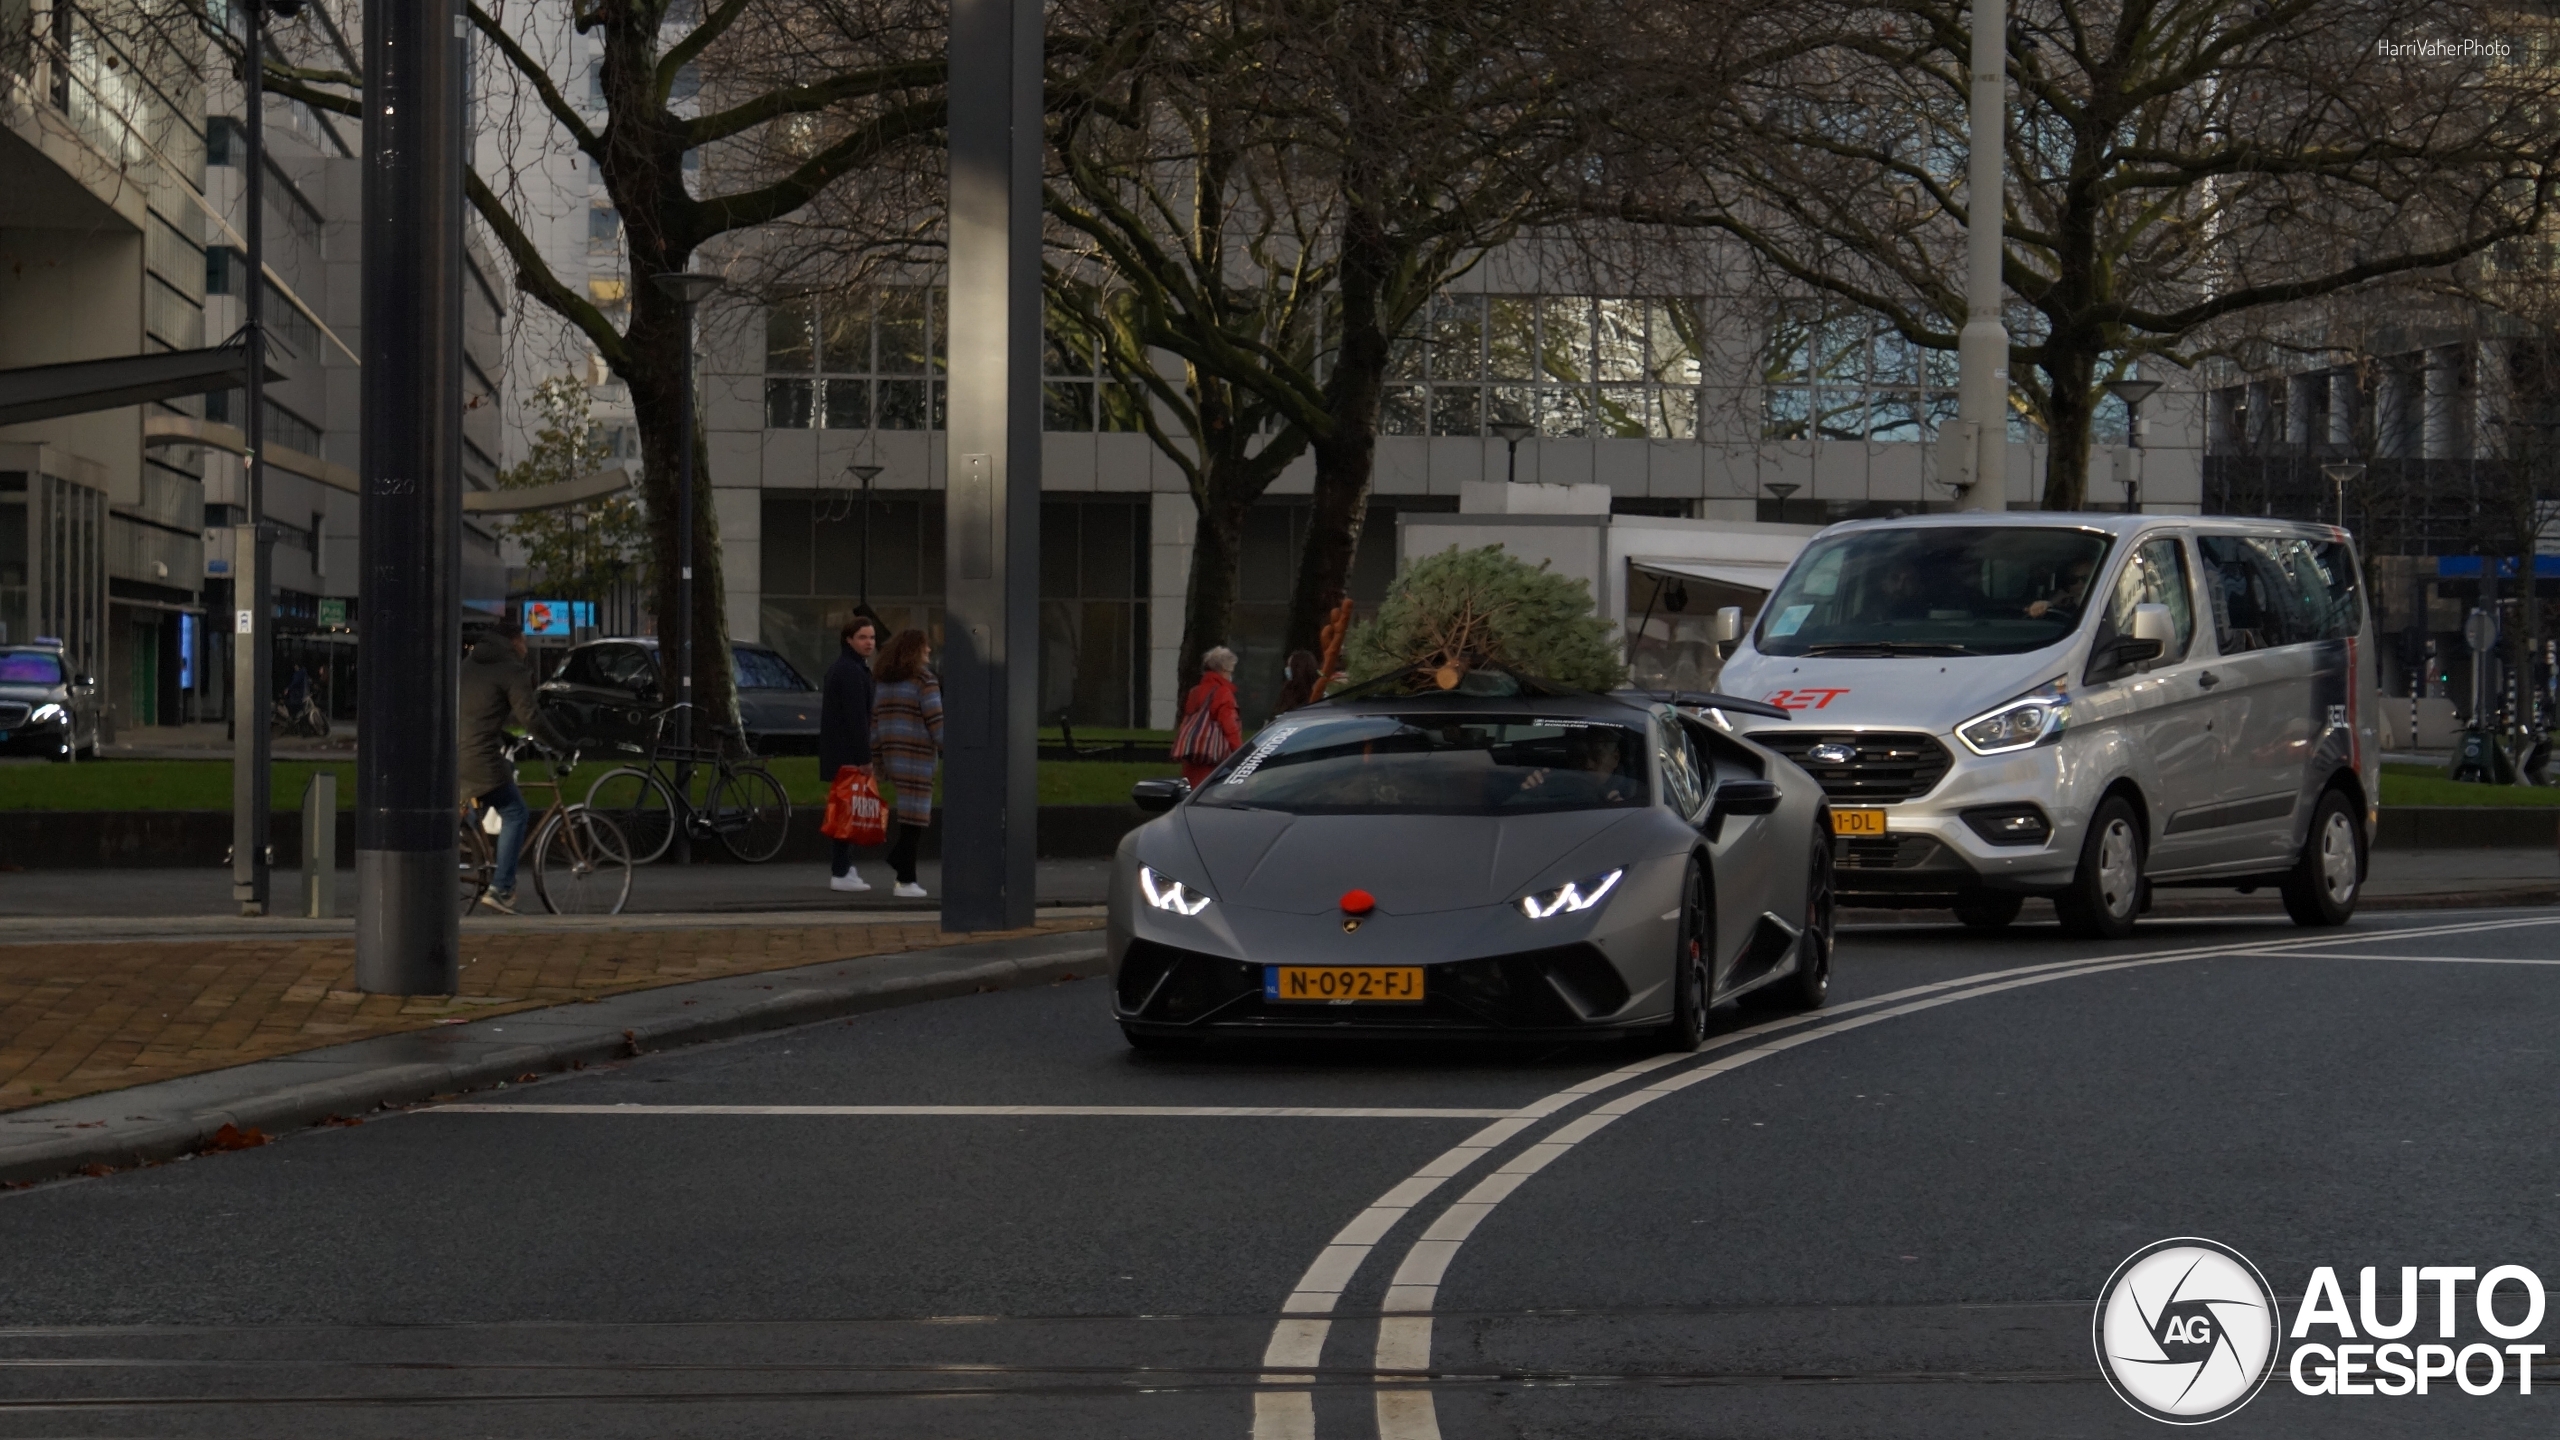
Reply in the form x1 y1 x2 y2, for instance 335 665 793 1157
1718 512 2381 938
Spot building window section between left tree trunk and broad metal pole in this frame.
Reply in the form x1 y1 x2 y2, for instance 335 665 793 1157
765 284 942 430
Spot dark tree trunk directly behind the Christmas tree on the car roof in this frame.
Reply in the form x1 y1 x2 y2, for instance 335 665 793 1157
1283 213 1393 650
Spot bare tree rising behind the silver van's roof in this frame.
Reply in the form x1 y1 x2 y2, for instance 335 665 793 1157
1613 0 2560 510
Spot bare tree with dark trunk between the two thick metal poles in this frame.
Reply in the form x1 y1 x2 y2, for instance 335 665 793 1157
266 0 945 712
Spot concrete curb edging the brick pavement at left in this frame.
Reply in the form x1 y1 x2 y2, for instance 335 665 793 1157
0 930 1103 1184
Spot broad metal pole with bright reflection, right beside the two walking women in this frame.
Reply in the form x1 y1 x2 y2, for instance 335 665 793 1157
942 0 1042 930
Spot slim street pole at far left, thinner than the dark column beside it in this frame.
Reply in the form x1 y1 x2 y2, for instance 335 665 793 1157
230 0 276 915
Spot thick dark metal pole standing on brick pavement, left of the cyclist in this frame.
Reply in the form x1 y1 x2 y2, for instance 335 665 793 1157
356 0 466 994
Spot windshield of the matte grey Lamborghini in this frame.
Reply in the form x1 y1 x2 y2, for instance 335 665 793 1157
1193 715 1646 815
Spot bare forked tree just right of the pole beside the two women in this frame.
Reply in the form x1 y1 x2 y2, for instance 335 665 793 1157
1047 0 1331 694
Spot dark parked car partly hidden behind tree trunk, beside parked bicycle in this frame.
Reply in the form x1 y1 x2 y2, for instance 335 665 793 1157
535 638 817 758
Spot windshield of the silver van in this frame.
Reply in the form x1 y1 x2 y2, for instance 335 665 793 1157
1751 525 2115 656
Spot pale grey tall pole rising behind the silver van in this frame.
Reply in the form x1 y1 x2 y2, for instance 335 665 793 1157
1956 0 2010 510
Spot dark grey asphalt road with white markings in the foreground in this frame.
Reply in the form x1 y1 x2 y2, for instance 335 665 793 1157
0 910 2560 1440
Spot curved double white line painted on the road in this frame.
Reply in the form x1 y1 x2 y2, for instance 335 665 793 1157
1254 917 2560 1440
